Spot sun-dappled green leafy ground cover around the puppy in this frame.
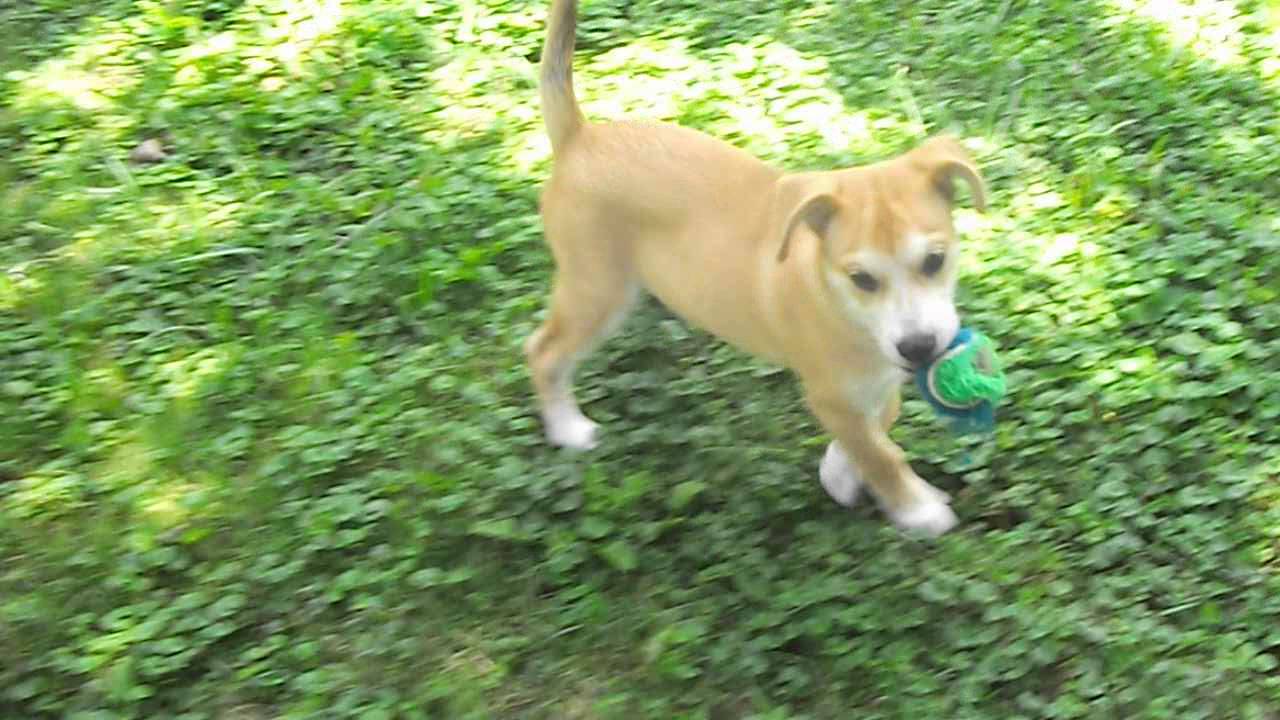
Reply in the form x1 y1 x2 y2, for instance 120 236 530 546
0 0 1280 720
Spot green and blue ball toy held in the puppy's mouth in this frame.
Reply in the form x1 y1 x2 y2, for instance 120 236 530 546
915 328 1005 434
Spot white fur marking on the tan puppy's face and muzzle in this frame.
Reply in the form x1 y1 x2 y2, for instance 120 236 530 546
841 233 960 365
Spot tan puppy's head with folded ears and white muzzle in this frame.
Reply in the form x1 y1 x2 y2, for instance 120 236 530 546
778 136 986 369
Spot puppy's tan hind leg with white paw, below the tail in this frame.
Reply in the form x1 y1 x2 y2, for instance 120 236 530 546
525 252 637 450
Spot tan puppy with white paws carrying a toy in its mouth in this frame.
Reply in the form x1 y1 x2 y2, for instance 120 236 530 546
525 0 986 534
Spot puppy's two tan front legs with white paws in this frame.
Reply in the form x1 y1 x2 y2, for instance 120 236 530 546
806 392 956 536
